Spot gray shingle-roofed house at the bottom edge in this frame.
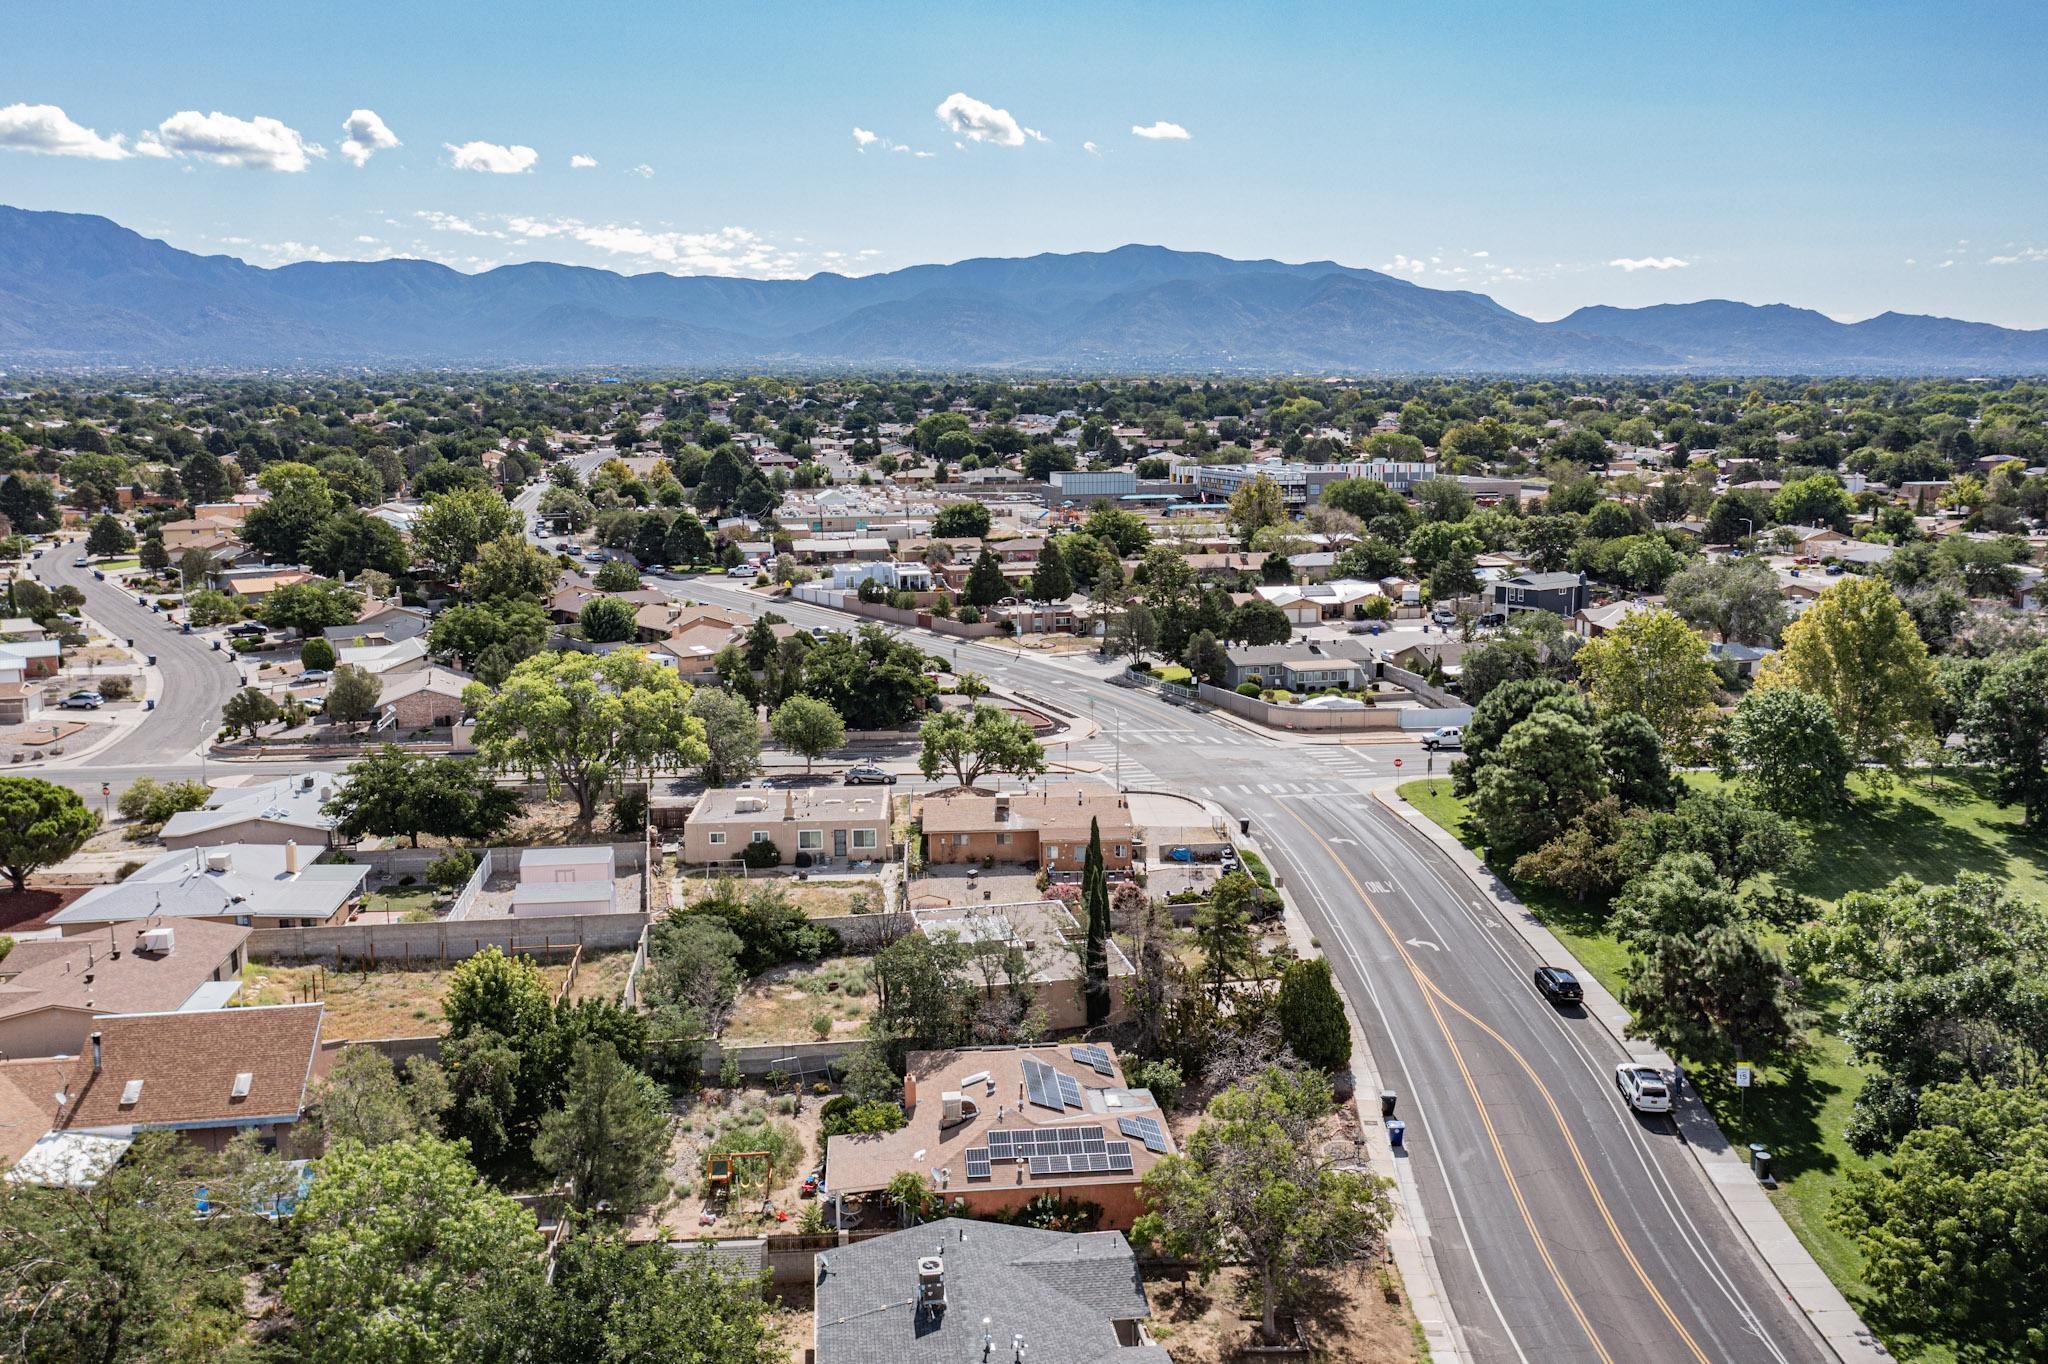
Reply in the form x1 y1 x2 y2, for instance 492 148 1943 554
813 1217 1171 1364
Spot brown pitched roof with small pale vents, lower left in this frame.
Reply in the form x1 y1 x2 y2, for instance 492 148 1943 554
59 999 326 1131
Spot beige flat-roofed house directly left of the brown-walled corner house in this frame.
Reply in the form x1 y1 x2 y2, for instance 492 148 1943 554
682 786 889 866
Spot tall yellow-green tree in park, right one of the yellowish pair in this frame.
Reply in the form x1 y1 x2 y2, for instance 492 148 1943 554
1757 578 1933 782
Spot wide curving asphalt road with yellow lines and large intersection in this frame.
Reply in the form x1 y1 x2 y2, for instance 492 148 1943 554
672 578 1831 1364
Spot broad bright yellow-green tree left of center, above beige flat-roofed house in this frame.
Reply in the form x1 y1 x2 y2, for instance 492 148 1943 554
463 649 708 823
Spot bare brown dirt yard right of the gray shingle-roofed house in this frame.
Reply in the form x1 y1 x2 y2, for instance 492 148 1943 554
1145 1266 1427 1364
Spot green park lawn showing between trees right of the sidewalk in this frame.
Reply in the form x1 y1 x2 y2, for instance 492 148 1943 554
1401 770 2048 1360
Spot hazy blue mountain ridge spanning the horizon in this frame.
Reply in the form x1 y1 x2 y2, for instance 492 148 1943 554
0 207 2048 375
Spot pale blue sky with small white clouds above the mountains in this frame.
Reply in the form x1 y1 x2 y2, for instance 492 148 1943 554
0 0 2048 328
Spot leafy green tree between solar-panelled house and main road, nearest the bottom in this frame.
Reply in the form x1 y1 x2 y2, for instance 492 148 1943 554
1130 1069 1393 1341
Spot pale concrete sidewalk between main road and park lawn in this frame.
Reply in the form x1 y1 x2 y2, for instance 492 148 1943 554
1372 788 1892 1364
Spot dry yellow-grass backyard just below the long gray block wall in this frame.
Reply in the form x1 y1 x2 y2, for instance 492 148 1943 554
242 952 633 1038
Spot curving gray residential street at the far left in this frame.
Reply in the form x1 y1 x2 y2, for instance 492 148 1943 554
31 539 242 772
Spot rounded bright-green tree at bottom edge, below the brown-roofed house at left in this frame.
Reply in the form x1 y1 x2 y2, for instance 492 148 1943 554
285 1137 543 1364
